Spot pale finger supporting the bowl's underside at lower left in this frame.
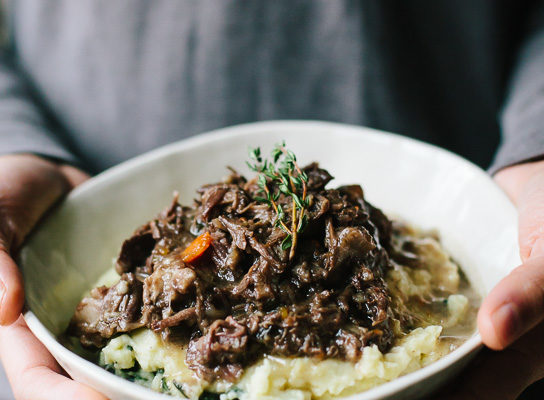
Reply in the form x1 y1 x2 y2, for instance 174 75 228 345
0 317 106 400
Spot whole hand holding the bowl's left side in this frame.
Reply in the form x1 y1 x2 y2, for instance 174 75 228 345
0 155 105 400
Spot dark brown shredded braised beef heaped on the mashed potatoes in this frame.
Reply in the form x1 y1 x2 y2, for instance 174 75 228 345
70 163 393 381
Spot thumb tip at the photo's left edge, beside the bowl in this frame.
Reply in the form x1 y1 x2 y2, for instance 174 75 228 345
0 252 24 325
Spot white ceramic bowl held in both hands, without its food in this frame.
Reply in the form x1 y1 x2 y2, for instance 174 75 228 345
20 121 519 400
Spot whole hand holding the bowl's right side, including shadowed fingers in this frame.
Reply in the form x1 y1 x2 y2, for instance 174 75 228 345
431 161 544 400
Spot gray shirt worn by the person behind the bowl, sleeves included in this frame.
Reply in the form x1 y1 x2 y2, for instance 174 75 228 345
0 0 544 172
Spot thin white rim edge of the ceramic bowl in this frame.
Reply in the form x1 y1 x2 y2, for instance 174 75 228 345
24 120 513 400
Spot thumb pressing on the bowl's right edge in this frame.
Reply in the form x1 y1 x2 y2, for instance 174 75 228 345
478 257 544 350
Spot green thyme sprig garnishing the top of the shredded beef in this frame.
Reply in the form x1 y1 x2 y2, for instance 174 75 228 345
247 141 309 260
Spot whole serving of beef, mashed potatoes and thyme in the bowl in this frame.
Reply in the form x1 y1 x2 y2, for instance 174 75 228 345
67 144 478 400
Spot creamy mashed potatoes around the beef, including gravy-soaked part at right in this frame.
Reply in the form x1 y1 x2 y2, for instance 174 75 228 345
100 228 473 400
